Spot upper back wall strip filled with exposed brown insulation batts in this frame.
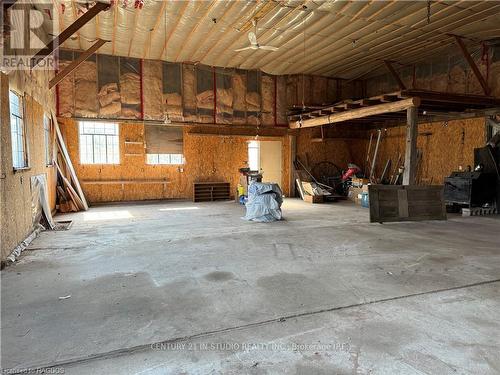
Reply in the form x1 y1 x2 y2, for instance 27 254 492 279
56 50 363 126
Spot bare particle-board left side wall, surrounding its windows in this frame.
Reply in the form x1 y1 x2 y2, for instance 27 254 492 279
0 70 57 260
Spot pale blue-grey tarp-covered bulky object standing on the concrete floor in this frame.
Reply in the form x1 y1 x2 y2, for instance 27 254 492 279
243 182 283 223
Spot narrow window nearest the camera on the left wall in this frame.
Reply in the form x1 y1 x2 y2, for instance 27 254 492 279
9 91 28 169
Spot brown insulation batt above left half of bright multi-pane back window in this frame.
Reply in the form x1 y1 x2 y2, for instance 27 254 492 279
73 61 98 117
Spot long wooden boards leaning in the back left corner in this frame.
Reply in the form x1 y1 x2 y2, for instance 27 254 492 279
52 114 89 212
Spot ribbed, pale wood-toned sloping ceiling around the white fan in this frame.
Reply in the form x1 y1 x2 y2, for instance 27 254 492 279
38 0 500 78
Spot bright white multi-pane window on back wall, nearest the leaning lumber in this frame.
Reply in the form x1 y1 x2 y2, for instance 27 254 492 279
79 121 120 164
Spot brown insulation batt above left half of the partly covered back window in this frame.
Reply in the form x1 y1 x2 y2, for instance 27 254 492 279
142 60 164 120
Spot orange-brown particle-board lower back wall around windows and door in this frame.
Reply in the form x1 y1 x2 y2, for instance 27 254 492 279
59 118 289 203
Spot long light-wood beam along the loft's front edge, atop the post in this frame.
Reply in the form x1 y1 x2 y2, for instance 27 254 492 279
289 97 420 129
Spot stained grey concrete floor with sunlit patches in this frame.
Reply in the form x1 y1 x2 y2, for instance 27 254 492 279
1 200 500 374
